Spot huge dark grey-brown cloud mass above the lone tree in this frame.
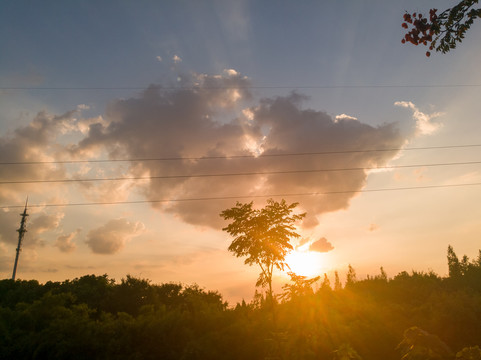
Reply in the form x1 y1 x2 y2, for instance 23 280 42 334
72 70 410 228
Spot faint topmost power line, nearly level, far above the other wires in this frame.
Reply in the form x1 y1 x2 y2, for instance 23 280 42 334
0 84 481 91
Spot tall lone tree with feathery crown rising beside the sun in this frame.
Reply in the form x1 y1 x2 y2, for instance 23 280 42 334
220 199 306 300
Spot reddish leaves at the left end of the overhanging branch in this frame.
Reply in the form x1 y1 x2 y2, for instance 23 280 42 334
401 9 437 56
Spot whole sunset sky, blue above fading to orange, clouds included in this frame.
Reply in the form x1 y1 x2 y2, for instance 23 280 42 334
0 0 481 302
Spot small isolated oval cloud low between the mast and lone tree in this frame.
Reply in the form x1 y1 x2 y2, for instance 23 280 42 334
85 218 144 254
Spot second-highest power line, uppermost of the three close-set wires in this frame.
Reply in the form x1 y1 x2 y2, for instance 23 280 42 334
0 144 481 165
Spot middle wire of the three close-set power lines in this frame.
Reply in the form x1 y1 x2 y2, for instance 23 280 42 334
0 161 481 185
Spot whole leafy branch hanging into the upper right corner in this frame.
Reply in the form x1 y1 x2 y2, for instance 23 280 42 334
402 0 481 56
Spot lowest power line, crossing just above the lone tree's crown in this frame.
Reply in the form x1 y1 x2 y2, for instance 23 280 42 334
0 182 481 210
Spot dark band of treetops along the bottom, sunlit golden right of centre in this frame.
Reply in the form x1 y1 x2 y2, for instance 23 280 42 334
0 247 481 360
